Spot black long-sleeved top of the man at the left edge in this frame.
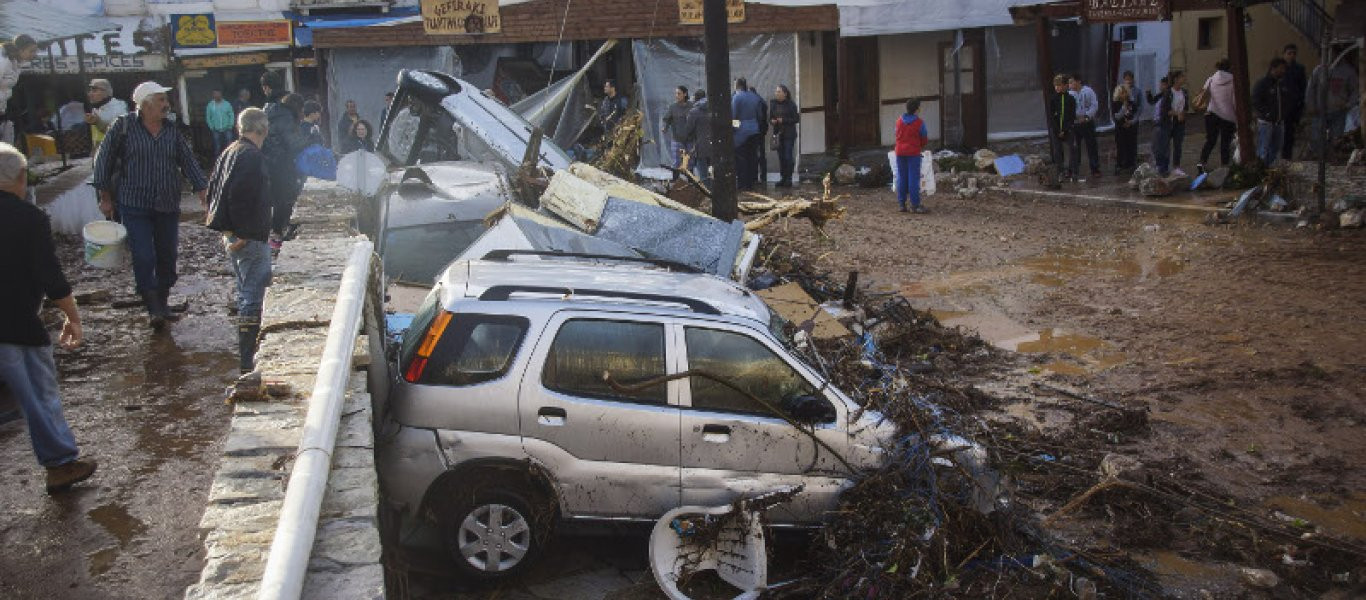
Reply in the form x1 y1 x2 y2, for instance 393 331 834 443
0 191 71 346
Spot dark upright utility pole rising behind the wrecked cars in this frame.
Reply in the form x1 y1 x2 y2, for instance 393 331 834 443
702 0 738 223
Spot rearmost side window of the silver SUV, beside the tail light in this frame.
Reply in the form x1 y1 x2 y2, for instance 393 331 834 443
418 313 527 385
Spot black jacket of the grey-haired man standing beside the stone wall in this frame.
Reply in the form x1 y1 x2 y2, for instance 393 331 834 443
204 138 270 242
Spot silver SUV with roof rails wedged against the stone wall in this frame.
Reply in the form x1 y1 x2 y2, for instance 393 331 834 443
376 250 892 578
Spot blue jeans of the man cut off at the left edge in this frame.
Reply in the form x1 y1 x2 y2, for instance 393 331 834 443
0 344 79 466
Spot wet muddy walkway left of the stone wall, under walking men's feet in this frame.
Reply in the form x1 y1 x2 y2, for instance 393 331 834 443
0 200 236 599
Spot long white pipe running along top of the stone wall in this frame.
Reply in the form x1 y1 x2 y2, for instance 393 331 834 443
257 242 373 600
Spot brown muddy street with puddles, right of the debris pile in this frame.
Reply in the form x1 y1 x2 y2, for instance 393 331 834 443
764 187 1366 597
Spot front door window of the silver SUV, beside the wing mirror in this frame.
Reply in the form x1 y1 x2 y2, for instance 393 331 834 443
684 327 814 415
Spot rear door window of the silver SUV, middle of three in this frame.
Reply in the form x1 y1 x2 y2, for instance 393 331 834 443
541 318 668 405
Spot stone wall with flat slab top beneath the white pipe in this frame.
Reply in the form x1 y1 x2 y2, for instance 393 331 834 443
184 185 384 599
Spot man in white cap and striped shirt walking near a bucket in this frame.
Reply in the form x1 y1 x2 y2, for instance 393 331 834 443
94 81 208 329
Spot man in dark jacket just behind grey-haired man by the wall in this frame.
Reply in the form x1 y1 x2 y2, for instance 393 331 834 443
261 71 309 253
